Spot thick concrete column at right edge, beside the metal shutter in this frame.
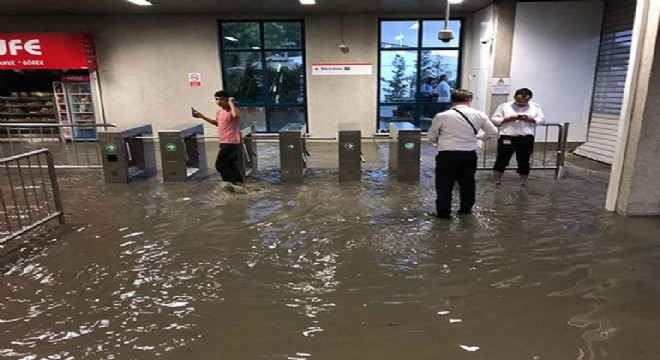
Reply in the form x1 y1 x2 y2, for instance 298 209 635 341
607 0 660 215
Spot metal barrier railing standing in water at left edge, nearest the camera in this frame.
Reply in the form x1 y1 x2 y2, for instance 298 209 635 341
0 149 64 244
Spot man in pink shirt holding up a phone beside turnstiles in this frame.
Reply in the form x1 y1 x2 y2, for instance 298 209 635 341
193 90 243 184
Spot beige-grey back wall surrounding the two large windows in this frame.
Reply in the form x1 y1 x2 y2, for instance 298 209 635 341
0 14 471 137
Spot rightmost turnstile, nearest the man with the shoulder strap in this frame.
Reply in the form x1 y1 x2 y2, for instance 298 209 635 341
389 122 422 181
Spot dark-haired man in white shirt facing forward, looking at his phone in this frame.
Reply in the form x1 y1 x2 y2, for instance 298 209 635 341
493 88 545 186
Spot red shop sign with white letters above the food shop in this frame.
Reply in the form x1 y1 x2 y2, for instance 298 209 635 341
0 33 97 70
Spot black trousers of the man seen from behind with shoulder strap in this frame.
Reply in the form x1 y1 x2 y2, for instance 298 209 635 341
435 151 477 215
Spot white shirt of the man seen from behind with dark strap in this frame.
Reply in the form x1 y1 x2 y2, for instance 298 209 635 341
428 105 497 151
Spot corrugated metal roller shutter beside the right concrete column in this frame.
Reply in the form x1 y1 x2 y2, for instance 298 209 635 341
574 0 636 164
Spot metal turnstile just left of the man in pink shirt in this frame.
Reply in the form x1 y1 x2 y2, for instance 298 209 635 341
158 124 206 182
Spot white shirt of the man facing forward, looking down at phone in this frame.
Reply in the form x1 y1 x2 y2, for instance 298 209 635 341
492 101 545 136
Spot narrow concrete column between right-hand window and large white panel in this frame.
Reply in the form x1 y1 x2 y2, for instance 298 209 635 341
488 0 516 115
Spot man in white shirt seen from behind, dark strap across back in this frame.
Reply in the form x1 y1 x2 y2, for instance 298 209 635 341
428 89 497 219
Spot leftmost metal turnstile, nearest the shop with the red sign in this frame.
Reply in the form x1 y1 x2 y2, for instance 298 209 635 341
98 124 156 183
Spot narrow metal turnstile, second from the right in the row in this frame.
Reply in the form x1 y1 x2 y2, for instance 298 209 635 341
338 123 362 181
